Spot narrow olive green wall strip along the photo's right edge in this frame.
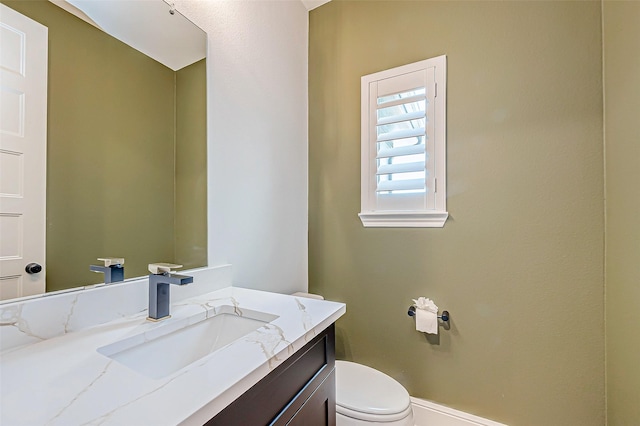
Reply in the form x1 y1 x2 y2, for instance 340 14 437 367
603 1 640 426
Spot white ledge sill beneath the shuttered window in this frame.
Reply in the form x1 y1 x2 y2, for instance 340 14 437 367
358 211 449 228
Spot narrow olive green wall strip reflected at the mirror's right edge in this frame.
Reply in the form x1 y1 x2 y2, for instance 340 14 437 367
175 59 207 268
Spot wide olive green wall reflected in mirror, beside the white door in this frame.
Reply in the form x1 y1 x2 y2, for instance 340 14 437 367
2 0 206 291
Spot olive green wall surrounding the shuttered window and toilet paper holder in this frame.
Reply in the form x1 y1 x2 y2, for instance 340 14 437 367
309 0 605 426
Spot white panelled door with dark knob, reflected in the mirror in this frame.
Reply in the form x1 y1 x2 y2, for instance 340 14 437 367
0 4 48 300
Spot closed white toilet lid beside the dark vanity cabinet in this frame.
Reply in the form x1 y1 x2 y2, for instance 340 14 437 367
336 361 411 415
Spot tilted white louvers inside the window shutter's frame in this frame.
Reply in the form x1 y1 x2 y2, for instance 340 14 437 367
375 87 427 194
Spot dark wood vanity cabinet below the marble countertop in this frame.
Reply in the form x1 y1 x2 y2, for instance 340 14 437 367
206 324 336 426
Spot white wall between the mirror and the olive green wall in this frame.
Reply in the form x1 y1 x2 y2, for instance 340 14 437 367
175 0 308 292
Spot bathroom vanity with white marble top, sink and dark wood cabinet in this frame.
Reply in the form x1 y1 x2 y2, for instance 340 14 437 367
0 268 345 426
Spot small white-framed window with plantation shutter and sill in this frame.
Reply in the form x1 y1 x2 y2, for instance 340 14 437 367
359 56 448 227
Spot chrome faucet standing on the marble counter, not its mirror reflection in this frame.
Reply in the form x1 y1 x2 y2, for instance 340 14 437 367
147 263 193 321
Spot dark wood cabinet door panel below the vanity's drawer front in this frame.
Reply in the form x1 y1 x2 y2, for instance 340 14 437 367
287 370 336 426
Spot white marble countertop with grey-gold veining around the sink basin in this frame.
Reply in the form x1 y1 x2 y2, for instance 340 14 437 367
0 287 345 426
